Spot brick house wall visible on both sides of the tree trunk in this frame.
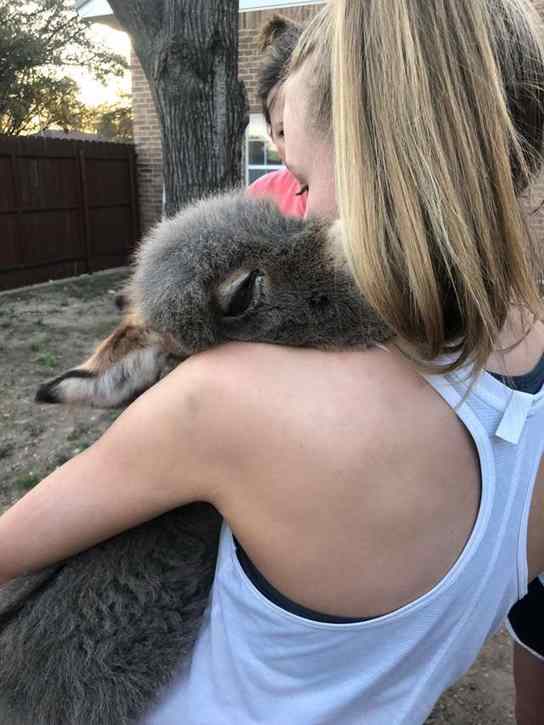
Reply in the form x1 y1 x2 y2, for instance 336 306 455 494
132 5 319 233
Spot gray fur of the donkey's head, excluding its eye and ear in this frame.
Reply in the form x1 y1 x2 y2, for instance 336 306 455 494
131 189 387 355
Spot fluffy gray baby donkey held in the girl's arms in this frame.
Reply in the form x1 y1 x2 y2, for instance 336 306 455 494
0 193 390 725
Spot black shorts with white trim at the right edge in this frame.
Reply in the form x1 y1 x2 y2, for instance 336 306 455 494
506 574 544 661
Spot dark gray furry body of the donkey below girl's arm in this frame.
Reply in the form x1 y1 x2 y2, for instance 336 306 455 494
0 504 221 725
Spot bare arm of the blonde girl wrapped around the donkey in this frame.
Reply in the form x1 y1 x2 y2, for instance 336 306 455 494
0 351 240 583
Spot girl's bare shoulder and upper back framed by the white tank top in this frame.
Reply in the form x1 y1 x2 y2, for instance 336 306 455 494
178 344 479 616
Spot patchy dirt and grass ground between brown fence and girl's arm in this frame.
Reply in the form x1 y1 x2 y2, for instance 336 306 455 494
0 270 127 504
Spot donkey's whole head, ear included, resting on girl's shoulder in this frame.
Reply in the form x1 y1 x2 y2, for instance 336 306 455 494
37 193 388 407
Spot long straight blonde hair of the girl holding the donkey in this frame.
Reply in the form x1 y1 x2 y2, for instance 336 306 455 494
293 0 544 370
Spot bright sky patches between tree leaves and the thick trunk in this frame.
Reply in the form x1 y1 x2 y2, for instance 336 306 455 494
68 23 130 106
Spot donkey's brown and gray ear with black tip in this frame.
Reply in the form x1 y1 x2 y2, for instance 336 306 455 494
36 315 180 408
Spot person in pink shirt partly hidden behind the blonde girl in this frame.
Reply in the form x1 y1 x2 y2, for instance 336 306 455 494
247 15 308 217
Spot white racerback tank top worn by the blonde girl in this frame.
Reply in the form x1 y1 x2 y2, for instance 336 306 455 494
145 372 544 725
